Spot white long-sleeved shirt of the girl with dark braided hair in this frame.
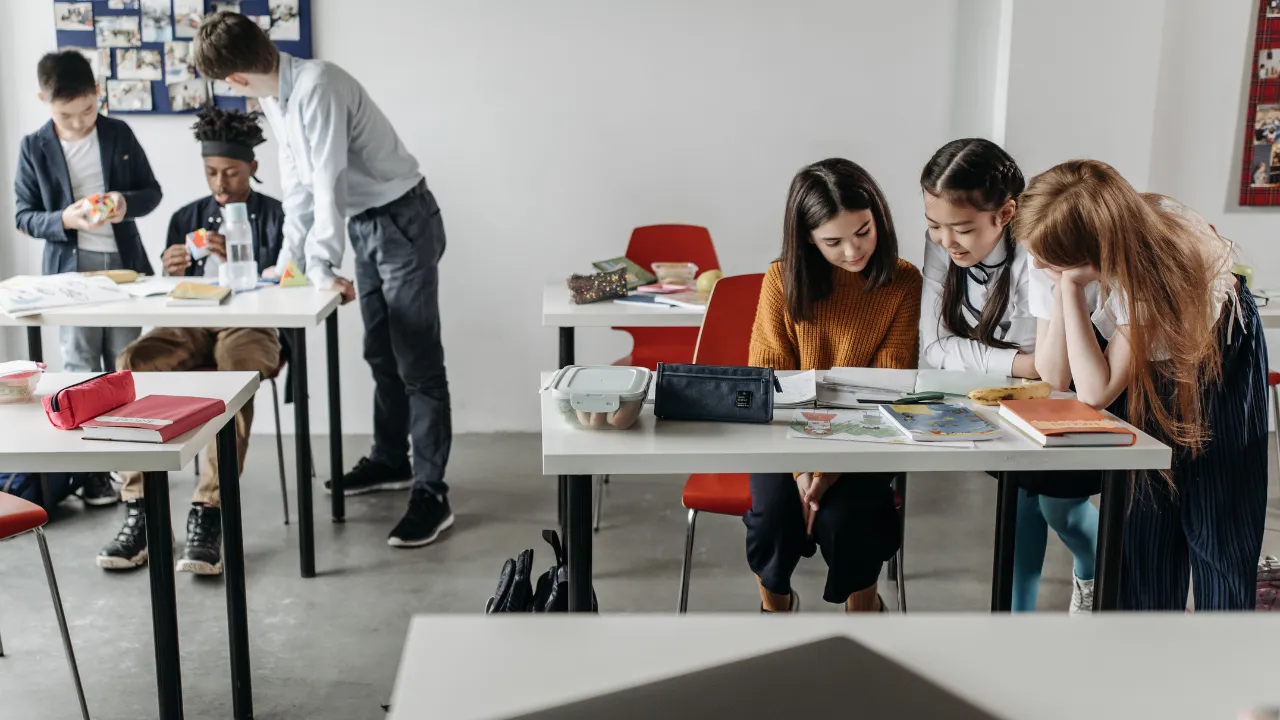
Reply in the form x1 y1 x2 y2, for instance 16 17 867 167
920 240 1036 375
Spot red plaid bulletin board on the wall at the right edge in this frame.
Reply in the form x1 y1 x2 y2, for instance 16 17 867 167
1240 0 1280 205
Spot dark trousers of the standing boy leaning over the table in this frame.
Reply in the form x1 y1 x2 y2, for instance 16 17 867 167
347 181 453 496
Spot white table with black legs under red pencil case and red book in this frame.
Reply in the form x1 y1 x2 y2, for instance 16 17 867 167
0 373 259 719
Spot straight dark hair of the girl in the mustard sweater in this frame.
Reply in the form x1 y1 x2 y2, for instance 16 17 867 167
782 158 897 322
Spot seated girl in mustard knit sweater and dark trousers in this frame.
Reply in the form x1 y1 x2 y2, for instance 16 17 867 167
744 159 922 612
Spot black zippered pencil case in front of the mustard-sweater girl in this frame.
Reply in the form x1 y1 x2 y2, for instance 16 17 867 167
653 363 782 423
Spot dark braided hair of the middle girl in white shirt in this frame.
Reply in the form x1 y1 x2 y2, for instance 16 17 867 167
920 137 1027 350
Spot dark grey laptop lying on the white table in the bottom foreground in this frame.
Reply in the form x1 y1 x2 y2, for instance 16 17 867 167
506 637 997 720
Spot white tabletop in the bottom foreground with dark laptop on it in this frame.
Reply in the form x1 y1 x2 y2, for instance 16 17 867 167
388 614 1280 720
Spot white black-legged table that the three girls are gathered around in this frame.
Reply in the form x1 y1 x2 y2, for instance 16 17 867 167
541 373 1172 611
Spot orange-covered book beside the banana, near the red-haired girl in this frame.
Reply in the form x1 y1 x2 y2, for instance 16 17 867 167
1000 398 1138 447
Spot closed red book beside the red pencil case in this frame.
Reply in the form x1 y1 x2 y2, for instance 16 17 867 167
81 395 227 443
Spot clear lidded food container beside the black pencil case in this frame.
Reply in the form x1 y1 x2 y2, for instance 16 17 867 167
547 365 653 430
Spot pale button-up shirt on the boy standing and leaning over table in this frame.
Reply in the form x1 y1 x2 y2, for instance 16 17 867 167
262 53 422 282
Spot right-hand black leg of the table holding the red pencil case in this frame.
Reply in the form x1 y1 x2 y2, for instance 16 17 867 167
218 419 253 720
